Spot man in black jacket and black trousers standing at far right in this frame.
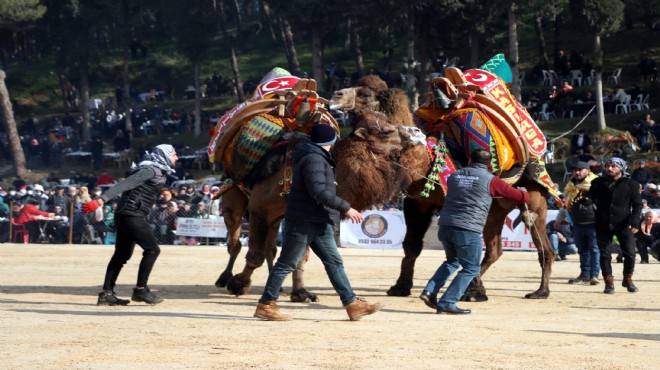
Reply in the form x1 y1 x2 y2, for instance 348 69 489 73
589 157 642 294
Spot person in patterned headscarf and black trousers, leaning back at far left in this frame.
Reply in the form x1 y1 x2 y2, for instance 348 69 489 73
82 144 178 306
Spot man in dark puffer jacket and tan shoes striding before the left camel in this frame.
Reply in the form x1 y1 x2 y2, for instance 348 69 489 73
254 124 381 321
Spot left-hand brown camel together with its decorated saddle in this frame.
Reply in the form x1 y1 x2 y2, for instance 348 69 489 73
209 70 410 302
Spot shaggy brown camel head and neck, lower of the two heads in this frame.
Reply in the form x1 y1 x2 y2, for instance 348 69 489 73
333 110 429 210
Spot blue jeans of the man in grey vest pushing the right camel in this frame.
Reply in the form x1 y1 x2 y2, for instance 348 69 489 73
424 225 482 309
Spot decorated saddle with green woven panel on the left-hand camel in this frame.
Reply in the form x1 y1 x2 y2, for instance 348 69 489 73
208 68 339 183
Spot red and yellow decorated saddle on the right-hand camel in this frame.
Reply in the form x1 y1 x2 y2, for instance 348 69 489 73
413 55 558 196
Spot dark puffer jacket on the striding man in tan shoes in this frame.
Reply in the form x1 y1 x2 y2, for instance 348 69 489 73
284 142 351 224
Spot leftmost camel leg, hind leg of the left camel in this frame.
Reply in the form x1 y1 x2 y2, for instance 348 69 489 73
215 187 248 288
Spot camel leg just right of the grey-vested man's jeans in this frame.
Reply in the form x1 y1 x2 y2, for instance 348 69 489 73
461 201 513 302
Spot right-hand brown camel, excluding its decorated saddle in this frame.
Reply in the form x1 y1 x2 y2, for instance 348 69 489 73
330 76 555 301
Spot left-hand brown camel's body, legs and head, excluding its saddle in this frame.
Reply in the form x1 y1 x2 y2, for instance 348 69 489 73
210 77 410 302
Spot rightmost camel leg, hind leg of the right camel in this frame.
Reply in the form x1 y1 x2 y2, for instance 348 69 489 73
525 183 555 299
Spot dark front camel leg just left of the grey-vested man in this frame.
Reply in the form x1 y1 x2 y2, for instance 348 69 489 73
387 198 433 297
